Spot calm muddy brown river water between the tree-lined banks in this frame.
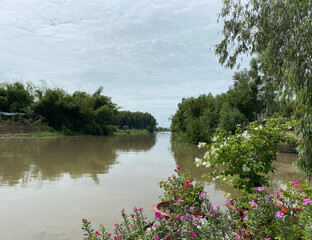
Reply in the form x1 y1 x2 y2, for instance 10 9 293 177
0 133 302 240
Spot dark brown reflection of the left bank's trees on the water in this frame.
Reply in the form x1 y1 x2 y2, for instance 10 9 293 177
0 135 156 186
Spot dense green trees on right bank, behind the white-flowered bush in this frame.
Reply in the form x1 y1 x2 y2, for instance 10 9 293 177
170 59 294 143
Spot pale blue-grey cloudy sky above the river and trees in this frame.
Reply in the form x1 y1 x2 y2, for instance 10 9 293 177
0 0 245 127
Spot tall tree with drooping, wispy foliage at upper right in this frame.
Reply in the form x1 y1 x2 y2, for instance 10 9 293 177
216 0 312 176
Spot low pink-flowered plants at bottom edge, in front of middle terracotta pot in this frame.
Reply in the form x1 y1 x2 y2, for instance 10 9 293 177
82 192 236 240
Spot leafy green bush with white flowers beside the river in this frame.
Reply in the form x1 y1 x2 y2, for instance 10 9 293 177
195 118 295 192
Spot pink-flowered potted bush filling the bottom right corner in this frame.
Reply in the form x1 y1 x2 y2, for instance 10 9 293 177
227 180 312 239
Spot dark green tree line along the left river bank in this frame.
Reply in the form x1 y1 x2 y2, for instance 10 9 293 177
0 82 157 135
